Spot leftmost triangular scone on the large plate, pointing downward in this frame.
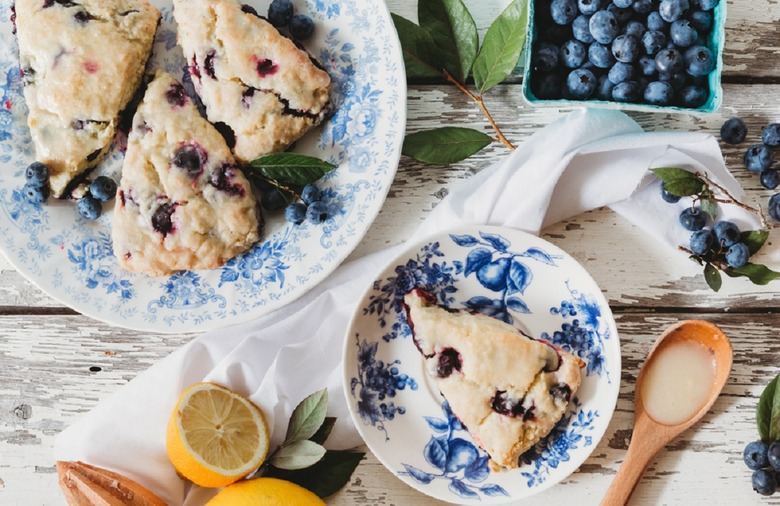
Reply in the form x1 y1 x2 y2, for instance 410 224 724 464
16 0 160 197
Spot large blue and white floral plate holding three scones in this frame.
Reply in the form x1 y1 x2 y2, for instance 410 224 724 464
0 0 406 332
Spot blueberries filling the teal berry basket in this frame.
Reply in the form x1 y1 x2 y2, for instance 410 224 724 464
531 0 718 108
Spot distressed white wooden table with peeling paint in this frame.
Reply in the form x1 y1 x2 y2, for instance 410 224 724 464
0 0 780 506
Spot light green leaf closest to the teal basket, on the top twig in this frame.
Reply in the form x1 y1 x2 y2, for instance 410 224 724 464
474 0 528 94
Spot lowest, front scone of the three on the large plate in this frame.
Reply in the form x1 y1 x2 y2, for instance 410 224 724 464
112 71 262 275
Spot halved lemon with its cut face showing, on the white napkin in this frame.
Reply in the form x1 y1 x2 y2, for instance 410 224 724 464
166 383 268 488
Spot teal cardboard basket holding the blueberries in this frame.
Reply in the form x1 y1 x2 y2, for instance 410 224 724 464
523 0 726 113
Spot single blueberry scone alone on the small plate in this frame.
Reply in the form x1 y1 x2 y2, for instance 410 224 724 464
404 288 583 469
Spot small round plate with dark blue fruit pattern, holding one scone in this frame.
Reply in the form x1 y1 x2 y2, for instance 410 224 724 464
344 226 621 504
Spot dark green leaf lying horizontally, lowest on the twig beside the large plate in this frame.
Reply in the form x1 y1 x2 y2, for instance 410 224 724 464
401 127 493 164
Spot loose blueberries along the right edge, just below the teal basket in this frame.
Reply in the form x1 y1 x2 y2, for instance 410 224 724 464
720 118 780 221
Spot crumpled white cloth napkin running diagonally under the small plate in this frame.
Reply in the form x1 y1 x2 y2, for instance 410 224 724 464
55 109 758 505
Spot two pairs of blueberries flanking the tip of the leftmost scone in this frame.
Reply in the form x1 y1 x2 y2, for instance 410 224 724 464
22 162 117 221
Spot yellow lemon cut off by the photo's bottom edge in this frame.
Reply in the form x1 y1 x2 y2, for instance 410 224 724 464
206 478 325 506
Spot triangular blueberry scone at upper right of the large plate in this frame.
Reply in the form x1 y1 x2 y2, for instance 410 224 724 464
173 0 330 163
